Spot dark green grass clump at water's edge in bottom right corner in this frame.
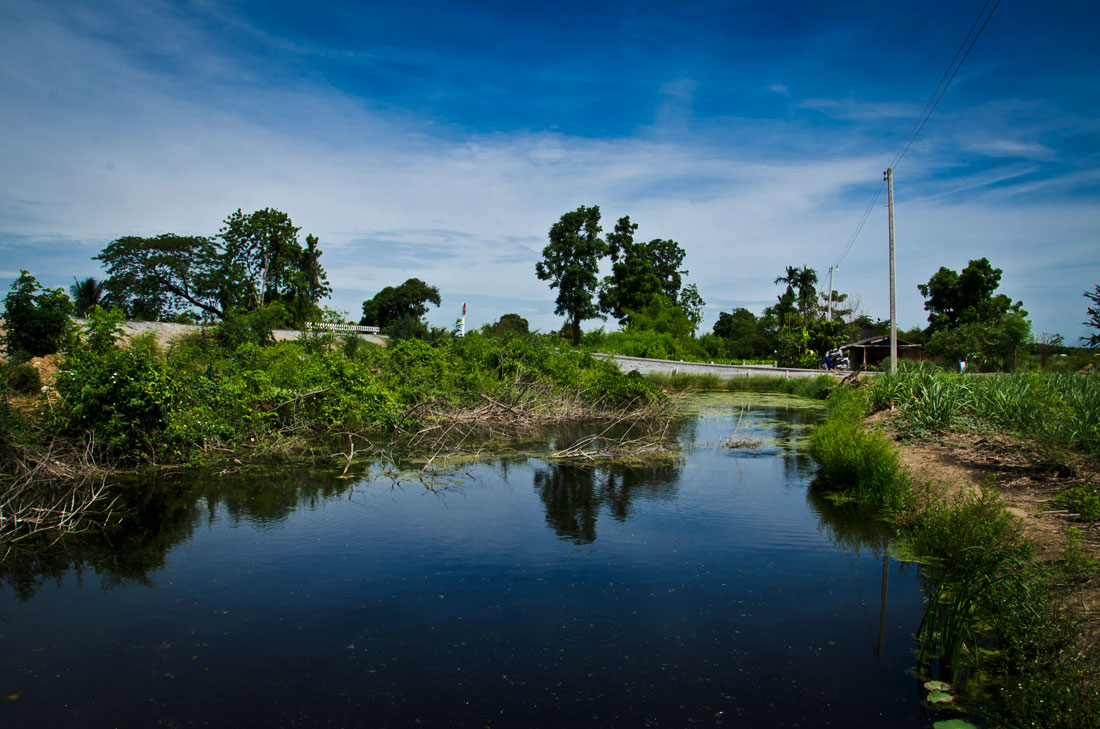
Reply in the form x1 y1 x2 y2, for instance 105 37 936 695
903 483 1100 729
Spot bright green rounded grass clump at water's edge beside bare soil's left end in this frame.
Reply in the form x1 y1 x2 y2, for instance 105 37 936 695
810 387 911 511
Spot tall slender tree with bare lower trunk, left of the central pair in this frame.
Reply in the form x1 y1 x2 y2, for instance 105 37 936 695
535 206 608 345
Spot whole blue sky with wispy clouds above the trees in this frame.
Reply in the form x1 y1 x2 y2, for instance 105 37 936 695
0 0 1100 341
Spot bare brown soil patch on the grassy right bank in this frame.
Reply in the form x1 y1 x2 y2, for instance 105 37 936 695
870 413 1100 643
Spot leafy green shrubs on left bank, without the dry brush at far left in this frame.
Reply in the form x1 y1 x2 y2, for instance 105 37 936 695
21 313 669 464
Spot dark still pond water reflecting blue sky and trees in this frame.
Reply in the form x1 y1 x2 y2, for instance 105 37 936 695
0 395 922 728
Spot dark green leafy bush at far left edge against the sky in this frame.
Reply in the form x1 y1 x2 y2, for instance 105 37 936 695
3 270 73 360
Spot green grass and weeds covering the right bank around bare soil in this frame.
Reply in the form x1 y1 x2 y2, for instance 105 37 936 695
811 378 1100 729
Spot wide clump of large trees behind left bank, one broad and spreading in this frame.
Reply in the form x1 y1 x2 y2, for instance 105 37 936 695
96 208 331 325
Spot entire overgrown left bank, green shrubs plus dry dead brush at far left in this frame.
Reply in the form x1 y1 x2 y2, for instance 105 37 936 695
0 308 673 547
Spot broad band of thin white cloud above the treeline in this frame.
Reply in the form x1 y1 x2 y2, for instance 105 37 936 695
0 0 1100 338
